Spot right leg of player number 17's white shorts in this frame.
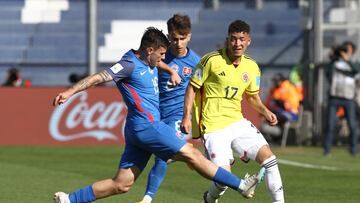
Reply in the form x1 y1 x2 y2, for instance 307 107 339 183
231 119 268 160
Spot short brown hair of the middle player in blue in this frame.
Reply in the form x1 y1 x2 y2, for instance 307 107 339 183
167 14 191 35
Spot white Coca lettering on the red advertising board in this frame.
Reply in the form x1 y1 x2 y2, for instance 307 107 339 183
49 91 126 141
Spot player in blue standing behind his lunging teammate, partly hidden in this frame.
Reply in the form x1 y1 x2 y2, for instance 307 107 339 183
139 14 200 203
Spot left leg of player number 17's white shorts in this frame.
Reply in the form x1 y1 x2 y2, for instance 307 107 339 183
203 128 234 166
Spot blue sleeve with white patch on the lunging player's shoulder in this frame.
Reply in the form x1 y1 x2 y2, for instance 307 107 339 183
106 60 135 82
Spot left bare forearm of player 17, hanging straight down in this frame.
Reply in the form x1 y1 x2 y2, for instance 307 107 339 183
180 83 197 134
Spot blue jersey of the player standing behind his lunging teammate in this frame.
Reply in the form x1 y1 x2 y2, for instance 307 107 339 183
159 49 200 119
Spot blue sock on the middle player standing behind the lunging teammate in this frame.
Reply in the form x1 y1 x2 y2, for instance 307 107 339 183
145 157 167 198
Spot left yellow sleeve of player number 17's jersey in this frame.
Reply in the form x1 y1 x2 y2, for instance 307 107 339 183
190 55 211 89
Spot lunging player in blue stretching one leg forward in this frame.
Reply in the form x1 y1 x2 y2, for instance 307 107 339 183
53 27 259 203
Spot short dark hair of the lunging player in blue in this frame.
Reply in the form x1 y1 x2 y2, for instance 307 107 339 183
140 27 170 49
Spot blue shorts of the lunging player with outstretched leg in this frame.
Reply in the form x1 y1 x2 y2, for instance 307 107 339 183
119 121 186 171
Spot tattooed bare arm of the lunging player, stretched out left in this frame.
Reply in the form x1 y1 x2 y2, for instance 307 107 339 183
53 70 113 106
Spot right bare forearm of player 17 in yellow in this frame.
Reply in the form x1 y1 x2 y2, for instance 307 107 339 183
245 94 278 125
